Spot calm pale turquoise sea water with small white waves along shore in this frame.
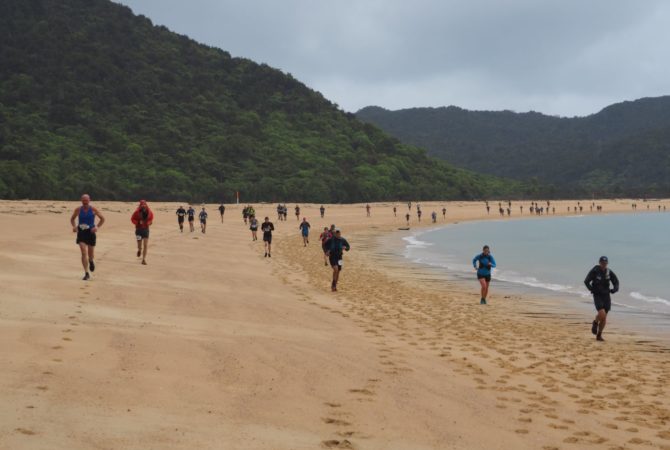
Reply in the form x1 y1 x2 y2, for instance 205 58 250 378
403 213 670 320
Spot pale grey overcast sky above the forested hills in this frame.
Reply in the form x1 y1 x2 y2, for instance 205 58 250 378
119 0 670 116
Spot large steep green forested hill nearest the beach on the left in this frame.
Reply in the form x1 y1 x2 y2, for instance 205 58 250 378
0 0 528 202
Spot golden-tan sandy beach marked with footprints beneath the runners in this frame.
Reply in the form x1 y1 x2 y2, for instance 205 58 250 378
0 201 670 450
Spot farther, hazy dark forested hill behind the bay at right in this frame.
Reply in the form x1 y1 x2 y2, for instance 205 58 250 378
357 96 670 196
